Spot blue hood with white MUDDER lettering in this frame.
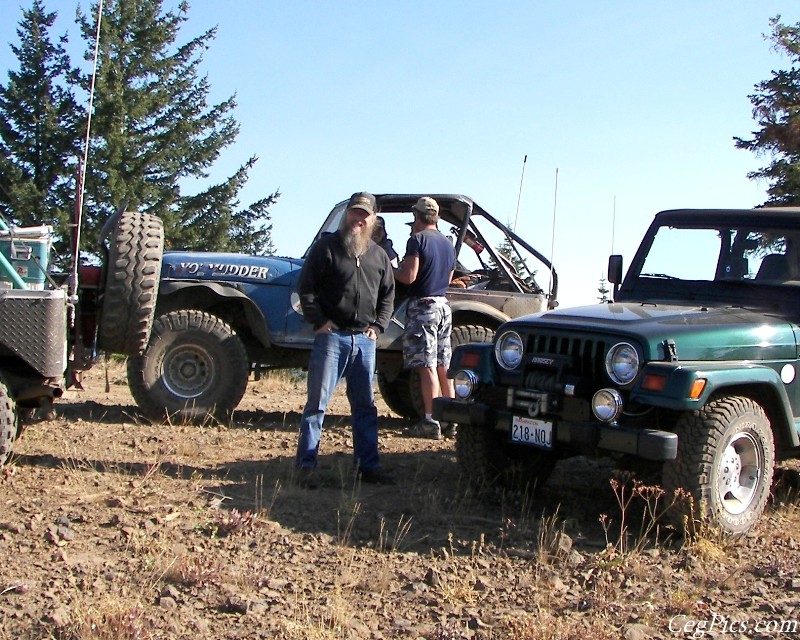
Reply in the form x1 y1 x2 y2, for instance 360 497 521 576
161 251 303 283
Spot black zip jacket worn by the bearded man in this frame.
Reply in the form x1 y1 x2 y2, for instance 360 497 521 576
297 231 394 333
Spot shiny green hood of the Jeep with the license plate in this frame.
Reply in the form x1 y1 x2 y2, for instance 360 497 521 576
506 302 797 360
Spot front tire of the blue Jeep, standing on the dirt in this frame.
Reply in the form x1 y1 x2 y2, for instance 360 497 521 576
128 310 250 424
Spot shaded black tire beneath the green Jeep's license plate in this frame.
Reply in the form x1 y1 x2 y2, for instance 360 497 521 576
456 424 558 492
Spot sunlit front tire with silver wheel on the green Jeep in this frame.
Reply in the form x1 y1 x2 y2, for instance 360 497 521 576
663 396 775 537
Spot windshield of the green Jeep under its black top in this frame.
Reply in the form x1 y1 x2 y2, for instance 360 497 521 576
622 218 800 303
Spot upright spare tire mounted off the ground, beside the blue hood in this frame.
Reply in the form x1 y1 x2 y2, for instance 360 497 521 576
97 211 164 355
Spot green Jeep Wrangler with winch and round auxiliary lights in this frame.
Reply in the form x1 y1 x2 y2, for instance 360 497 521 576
434 208 800 536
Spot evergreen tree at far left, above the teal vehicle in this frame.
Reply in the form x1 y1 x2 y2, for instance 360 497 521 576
0 0 83 240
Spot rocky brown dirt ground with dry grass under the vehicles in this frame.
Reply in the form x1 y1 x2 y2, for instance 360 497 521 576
0 363 800 640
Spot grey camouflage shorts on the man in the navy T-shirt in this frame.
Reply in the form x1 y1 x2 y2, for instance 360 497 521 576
403 296 453 369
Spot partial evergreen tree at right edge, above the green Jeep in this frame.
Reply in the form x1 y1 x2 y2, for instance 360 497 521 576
734 16 800 205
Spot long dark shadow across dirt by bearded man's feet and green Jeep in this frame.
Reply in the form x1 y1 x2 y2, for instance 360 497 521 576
14 440 620 554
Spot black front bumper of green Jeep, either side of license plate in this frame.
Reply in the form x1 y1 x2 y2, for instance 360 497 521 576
433 398 678 460
